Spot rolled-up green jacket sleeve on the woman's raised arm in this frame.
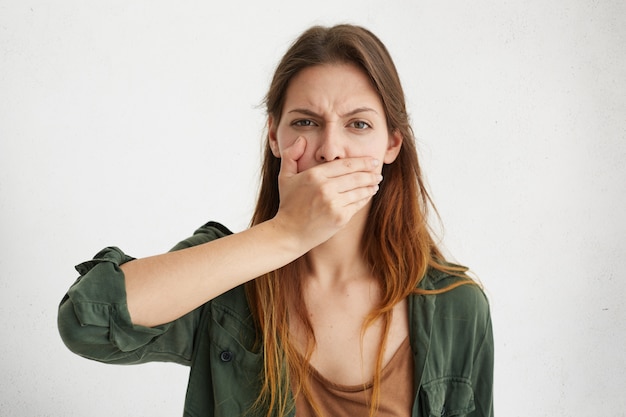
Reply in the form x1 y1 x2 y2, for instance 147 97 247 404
58 222 231 365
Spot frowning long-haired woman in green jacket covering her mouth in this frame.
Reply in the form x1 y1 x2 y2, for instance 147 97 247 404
59 25 493 417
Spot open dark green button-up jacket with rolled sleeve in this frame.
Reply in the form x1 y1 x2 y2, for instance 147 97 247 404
58 222 493 417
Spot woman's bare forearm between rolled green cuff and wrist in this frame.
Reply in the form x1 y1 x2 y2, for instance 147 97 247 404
121 216 308 327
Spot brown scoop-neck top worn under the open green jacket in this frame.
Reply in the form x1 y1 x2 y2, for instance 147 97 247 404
296 337 414 417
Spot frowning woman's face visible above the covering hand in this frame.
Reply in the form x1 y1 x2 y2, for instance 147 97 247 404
269 64 402 172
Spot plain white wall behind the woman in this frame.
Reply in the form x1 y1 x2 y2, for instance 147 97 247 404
0 0 626 417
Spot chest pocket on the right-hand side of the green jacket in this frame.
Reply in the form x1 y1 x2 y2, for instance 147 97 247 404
420 378 476 417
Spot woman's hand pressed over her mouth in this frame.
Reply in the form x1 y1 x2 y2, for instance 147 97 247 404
274 137 382 250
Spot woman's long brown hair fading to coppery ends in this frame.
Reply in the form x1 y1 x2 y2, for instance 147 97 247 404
246 25 463 416
